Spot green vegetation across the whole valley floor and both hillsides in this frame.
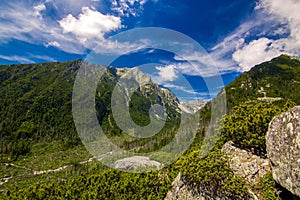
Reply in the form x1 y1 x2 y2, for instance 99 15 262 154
0 55 300 200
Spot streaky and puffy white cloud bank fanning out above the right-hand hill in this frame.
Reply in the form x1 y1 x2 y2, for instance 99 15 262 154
209 0 300 72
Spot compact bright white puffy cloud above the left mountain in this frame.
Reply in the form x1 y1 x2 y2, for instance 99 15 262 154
59 7 121 44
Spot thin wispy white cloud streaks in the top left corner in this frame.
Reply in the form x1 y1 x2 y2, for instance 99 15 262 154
0 1 83 53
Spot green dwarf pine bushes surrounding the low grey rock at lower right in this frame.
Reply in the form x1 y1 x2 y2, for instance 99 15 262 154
177 101 295 199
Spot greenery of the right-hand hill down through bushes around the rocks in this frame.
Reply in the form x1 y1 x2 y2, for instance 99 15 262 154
178 55 300 199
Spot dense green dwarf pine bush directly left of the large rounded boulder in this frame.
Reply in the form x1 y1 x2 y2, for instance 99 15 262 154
220 101 295 157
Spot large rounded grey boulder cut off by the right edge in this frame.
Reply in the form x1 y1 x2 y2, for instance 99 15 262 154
266 106 300 197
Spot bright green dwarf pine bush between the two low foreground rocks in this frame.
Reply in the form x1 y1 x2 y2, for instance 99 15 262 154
177 149 249 199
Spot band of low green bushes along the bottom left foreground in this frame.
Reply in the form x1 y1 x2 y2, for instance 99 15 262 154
5 170 173 200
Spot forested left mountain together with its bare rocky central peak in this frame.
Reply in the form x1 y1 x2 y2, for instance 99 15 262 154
0 60 180 158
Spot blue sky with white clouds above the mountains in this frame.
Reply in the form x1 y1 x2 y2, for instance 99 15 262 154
0 0 300 100
